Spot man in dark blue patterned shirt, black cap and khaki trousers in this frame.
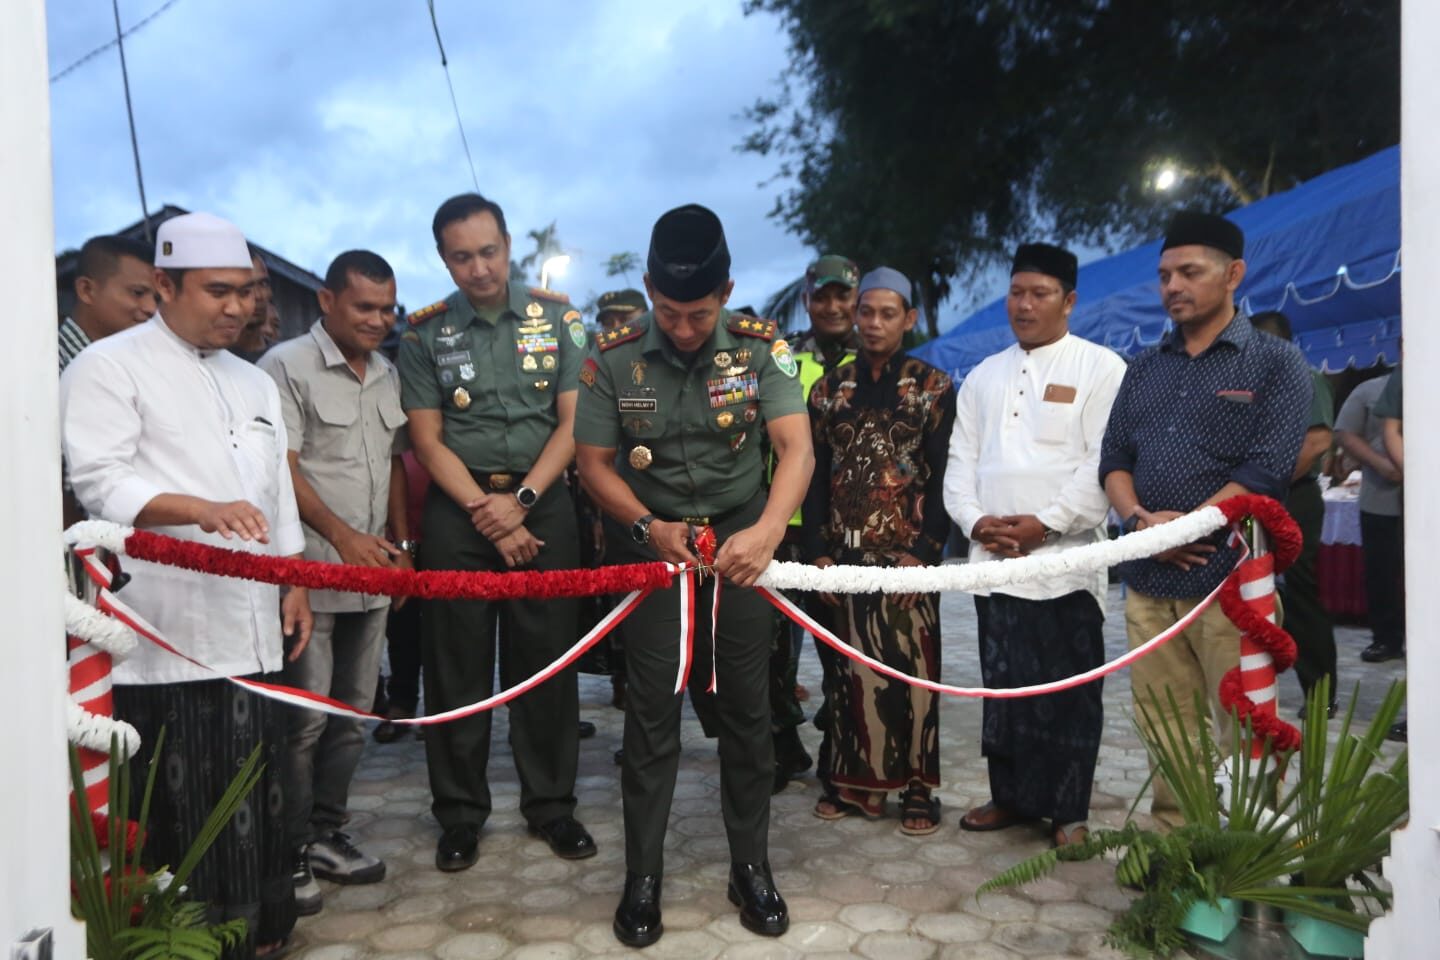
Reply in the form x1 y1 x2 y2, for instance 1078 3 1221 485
1100 212 1312 825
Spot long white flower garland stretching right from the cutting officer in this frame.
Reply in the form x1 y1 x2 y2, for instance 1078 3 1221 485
757 507 1230 593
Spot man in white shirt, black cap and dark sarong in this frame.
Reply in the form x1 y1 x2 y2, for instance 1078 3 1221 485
945 243 1125 846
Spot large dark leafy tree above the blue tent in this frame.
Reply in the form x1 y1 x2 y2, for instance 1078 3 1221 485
740 0 1400 334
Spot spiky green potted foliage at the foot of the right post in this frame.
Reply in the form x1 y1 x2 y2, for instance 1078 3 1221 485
976 682 1408 957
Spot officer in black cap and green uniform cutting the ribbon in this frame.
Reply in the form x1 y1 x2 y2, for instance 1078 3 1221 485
575 204 815 947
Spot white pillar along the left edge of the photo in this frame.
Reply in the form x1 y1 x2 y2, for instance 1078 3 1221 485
0 0 85 960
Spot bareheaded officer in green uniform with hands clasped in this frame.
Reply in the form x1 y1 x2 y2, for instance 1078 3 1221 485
399 193 595 871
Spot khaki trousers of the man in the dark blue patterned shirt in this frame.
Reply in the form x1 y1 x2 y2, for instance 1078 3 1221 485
1125 590 1240 826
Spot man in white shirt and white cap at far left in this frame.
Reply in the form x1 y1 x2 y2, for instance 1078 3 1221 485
60 213 311 954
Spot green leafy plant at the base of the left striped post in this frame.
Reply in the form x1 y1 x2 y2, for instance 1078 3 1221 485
71 731 261 960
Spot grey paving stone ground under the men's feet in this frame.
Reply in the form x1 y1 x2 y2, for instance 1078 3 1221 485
291 587 1404 960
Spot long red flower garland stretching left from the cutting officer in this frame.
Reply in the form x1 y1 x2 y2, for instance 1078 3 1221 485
125 530 674 600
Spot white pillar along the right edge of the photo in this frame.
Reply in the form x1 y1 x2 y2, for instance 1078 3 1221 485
1365 0 1440 960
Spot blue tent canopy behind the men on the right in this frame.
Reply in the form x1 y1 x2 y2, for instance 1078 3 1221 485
914 147 1400 379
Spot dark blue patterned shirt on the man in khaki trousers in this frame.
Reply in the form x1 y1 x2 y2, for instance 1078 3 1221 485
1100 311 1313 597
